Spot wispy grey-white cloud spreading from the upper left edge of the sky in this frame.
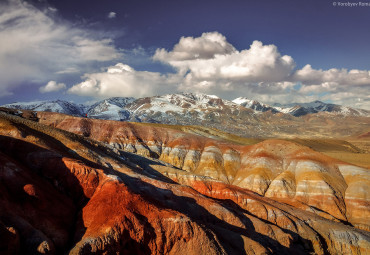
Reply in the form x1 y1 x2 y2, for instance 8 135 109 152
0 0 121 96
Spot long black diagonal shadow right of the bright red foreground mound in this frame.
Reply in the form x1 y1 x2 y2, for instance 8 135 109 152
107 167 313 254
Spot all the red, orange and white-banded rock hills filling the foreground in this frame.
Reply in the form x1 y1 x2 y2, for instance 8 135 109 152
0 110 370 254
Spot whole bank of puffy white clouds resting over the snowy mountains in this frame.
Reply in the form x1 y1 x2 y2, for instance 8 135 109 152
69 32 370 109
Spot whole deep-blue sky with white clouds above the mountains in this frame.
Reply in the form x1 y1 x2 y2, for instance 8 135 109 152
0 0 370 109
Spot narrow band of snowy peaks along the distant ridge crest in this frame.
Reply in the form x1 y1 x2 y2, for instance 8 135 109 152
2 93 370 120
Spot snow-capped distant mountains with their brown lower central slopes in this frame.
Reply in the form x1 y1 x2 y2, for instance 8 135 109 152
3 93 370 121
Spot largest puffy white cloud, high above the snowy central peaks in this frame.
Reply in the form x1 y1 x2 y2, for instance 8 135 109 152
153 32 295 82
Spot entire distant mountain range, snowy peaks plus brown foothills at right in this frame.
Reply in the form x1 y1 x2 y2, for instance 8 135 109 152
3 93 370 137
